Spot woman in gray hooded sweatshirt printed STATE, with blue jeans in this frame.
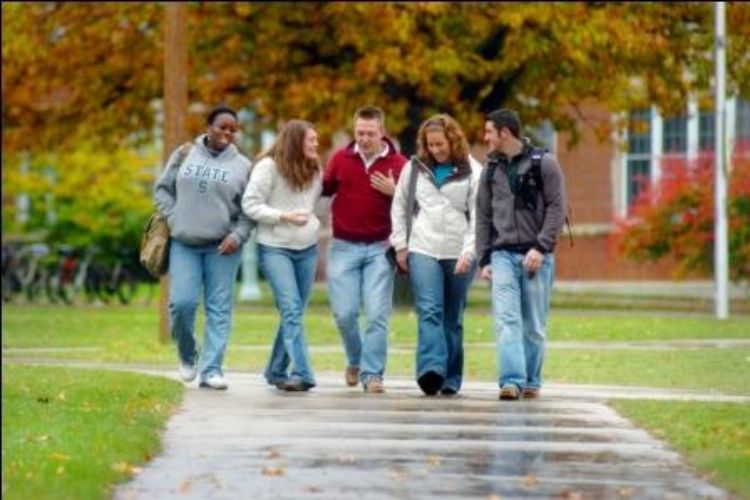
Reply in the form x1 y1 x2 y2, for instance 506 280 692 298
154 106 253 390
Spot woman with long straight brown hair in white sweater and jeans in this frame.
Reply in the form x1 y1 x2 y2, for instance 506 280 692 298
242 120 322 391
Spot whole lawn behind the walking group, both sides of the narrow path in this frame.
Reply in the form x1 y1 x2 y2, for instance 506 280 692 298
2 306 750 394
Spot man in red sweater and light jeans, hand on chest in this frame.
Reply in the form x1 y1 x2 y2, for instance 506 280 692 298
323 106 407 393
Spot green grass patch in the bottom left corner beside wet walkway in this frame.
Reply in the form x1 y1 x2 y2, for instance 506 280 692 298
2 364 183 499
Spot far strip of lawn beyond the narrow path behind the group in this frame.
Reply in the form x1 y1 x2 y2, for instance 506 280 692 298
2 305 750 348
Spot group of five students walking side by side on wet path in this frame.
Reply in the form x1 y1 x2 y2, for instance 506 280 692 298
154 106 565 400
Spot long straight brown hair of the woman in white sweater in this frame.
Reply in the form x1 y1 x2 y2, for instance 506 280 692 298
258 120 320 191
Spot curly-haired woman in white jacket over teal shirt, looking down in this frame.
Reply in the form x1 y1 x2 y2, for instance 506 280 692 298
391 114 481 396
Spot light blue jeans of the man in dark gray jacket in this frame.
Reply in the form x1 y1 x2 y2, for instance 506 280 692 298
492 250 555 389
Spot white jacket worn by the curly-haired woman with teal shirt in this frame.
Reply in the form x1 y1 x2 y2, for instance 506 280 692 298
390 156 482 260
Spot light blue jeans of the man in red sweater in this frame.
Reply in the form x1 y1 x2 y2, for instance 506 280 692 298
326 239 395 382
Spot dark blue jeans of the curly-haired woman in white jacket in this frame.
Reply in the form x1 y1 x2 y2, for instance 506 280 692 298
408 253 476 391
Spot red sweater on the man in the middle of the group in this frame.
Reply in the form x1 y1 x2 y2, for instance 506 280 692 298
323 139 406 243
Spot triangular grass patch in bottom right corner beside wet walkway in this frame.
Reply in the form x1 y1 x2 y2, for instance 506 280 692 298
610 400 750 498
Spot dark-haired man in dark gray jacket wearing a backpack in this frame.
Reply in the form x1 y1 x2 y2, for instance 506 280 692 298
476 109 565 400
